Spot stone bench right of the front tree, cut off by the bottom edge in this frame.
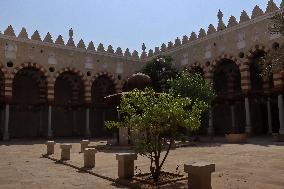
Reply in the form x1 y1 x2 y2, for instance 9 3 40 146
184 162 215 189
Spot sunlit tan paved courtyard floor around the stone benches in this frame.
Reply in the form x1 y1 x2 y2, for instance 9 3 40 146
0 138 284 189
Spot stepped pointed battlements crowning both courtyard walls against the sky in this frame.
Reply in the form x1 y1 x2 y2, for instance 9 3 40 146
0 0 284 61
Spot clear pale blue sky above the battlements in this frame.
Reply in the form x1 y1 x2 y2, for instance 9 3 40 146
0 0 281 52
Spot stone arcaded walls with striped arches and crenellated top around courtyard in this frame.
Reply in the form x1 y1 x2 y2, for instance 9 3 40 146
0 0 284 140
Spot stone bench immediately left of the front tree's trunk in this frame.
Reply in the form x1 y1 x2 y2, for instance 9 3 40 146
116 153 137 179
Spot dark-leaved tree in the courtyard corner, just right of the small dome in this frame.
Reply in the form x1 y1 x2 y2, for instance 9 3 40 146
142 56 178 92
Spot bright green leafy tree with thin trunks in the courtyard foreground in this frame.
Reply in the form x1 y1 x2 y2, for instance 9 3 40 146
107 88 207 183
